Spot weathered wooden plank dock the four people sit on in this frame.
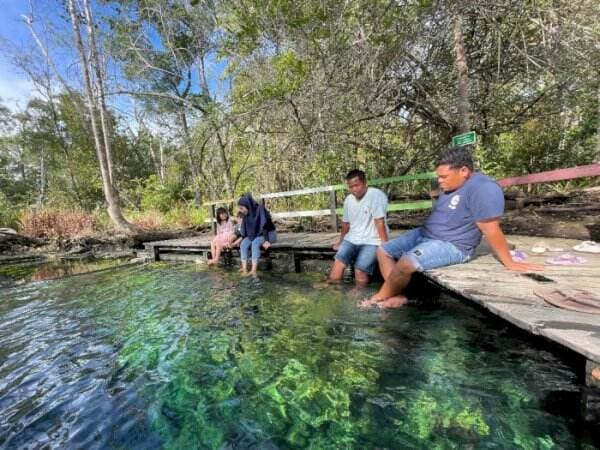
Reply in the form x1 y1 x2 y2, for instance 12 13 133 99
145 231 600 420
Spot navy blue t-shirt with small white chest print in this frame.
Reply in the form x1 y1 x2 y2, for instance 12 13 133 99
422 172 504 253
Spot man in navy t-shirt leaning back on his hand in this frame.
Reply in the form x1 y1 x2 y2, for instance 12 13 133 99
362 147 543 308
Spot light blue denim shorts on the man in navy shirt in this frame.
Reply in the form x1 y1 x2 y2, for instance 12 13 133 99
381 228 473 272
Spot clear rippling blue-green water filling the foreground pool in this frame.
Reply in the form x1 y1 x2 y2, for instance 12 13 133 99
0 264 599 449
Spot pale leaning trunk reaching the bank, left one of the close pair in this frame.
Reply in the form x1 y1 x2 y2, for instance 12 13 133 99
68 0 135 234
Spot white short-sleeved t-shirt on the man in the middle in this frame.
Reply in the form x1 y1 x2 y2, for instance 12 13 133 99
342 187 388 245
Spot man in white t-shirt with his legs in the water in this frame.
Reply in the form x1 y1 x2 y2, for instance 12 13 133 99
328 169 388 285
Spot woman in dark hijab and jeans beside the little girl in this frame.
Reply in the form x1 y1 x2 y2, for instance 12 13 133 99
238 193 277 276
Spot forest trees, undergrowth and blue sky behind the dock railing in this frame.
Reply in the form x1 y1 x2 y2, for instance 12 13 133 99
0 0 600 235
